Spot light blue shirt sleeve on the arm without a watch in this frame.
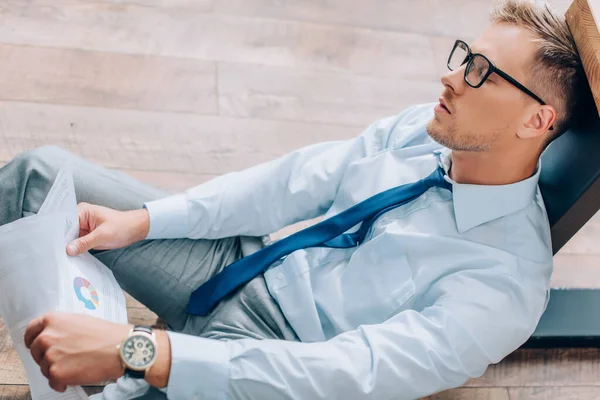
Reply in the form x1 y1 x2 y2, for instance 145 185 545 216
144 110 408 239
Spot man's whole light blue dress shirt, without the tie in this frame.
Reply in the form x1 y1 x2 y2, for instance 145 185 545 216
146 104 552 400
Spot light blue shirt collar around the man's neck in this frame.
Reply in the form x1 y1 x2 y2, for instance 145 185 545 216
434 149 542 233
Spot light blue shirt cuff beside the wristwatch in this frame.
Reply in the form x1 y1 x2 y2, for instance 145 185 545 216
167 332 229 400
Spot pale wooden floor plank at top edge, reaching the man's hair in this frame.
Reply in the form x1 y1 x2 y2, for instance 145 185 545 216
214 0 492 36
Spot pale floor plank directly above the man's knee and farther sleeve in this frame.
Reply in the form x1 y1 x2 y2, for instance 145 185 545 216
0 102 362 175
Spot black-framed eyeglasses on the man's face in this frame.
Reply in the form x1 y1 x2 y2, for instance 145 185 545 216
448 40 552 130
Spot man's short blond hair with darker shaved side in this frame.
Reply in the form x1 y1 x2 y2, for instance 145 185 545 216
490 0 592 142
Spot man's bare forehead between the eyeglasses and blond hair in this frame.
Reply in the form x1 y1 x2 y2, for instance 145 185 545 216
469 24 535 79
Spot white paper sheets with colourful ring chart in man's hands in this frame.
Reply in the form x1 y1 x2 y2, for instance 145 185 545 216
0 169 127 400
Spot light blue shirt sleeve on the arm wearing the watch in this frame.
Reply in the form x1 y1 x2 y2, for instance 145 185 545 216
162 268 547 400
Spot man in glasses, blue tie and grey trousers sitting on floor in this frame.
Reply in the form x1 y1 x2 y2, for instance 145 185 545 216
0 1 587 400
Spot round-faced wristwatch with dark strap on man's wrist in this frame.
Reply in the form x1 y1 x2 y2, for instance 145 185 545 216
117 325 158 379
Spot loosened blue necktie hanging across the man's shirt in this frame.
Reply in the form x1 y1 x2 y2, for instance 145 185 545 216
187 167 452 316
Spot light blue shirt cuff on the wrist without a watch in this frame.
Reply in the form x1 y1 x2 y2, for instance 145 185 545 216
144 194 189 239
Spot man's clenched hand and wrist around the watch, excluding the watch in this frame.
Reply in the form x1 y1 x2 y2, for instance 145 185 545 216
25 313 171 392
